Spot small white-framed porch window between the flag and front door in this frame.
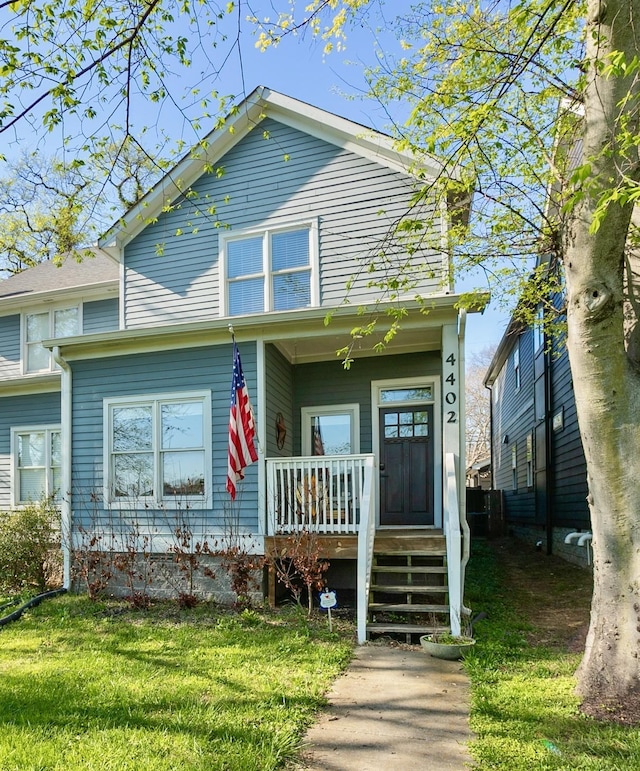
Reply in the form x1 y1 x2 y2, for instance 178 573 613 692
301 404 360 455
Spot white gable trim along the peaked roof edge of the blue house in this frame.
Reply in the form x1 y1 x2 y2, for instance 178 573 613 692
99 86 450 250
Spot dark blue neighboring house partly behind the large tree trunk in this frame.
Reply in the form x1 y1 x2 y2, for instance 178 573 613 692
485 296 591 564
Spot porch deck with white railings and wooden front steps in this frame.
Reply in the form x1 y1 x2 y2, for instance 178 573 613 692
265 453 464 643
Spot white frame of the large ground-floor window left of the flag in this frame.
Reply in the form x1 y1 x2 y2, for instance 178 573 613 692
102 391 213 510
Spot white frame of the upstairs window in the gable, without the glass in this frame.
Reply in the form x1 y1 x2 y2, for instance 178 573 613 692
218 218 320 318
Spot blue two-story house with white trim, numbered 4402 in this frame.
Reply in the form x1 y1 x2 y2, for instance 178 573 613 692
0 88 484 640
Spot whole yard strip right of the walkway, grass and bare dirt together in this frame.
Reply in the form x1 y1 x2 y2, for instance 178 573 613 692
465 539 640 771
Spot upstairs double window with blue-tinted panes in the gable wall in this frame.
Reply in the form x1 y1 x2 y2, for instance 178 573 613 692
221 224 316 316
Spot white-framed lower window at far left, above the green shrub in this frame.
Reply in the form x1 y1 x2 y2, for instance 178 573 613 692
11 426 62 506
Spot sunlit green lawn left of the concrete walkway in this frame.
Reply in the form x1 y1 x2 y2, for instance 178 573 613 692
0 596 353 771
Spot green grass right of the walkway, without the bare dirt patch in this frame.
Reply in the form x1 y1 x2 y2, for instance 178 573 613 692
465 542 640 771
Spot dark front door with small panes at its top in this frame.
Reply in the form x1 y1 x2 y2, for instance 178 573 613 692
380 404 434 525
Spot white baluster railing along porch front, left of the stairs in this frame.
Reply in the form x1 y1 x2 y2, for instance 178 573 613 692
267 455 373 535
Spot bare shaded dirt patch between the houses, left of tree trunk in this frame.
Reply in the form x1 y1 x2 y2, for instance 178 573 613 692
488 538 593 653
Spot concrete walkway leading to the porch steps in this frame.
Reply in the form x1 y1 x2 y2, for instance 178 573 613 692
298 645 472 771
